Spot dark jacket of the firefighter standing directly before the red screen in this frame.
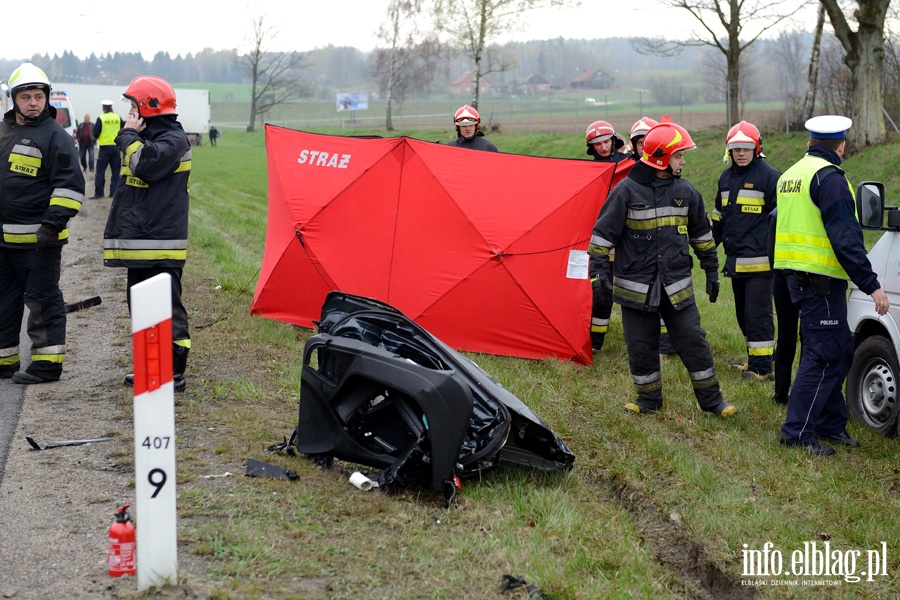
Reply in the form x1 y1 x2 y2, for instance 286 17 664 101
589 163 719 312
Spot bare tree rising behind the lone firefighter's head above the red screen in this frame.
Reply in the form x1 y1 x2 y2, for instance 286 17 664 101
435 0 573 108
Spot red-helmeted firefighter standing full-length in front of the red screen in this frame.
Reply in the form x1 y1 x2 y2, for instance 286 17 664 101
589 123 737 417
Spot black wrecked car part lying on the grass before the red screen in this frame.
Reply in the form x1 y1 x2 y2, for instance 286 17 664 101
295 292 575 501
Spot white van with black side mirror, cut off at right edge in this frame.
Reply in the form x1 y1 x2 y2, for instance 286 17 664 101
847 181 900 435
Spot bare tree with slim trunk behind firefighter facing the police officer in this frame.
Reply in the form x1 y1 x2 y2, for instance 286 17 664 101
634 0 802 125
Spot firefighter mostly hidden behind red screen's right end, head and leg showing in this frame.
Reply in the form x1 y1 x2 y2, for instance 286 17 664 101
585 121 628 353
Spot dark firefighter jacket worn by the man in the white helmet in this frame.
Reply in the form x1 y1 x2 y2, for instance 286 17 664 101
0 106 84 248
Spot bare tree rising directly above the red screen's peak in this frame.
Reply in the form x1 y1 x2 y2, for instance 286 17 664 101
372 0 440 131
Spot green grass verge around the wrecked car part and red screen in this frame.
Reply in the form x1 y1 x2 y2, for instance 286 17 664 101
162 124 900 599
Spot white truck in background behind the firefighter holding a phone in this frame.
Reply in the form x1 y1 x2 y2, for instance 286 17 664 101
52 83 210 146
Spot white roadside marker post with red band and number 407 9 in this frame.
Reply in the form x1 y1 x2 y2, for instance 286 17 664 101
131 273 178 591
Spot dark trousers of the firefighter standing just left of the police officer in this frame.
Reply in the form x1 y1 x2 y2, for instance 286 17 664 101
731 275 775 375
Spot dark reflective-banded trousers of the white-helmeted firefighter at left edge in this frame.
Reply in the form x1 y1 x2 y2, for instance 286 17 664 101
0 246 66 380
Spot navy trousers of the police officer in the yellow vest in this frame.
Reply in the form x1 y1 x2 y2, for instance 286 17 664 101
781 273 853 445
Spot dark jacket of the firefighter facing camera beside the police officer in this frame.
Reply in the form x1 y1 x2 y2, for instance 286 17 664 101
712 156 781 277
